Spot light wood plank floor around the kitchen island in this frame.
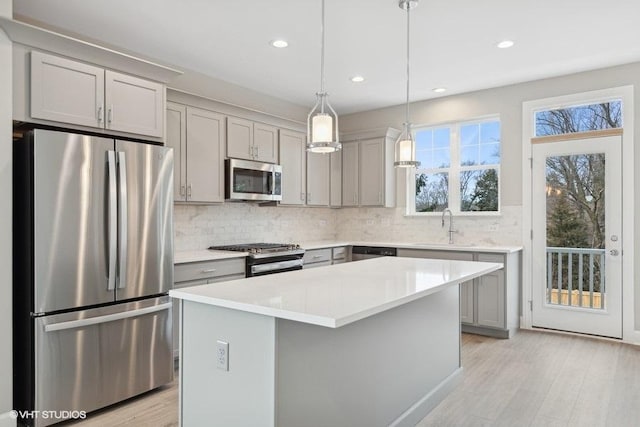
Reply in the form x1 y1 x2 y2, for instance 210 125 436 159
61 331 640 427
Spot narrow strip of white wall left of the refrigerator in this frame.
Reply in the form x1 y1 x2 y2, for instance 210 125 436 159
0 0 15 426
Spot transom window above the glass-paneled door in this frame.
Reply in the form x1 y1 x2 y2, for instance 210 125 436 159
535 100 622 136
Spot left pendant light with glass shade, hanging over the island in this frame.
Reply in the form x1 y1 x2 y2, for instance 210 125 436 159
307 0 342 153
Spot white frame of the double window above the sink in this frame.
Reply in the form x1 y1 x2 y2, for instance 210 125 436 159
405 115 503 217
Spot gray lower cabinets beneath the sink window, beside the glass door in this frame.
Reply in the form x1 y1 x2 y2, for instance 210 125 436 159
398 248 520 338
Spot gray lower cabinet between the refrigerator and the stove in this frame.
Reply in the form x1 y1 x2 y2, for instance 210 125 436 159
173 258 245 358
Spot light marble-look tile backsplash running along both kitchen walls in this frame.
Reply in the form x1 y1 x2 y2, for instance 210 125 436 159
174 203 522 251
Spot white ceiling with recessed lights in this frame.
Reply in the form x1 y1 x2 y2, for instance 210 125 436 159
13 0 640 114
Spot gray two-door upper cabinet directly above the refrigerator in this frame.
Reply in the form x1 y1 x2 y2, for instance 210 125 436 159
30 51 165 137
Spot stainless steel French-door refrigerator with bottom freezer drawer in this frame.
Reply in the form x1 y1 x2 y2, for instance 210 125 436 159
13 129 173 427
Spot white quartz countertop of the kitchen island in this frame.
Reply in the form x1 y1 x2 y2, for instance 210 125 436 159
169 257 503 328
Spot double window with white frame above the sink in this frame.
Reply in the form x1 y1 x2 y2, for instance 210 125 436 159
407 118 500 214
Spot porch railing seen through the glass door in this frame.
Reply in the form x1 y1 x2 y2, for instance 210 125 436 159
547 247 605 309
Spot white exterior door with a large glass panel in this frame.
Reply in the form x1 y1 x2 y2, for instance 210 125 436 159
532 136 622 338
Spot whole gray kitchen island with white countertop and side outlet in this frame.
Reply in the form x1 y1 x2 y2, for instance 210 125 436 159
170 257 502 427
